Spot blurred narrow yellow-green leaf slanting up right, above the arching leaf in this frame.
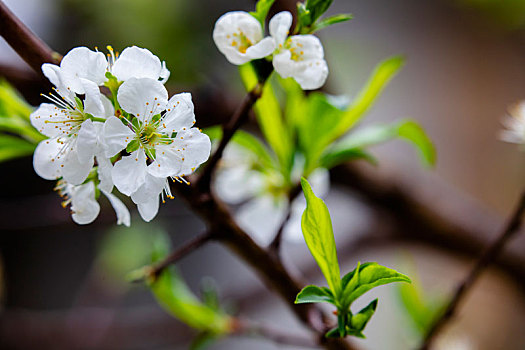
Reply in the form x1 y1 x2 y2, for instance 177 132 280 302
329 56 405 143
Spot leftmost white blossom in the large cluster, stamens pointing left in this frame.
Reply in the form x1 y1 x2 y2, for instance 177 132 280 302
30 54 114 185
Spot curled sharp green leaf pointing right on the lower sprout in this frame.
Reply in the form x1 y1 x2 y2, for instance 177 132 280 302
342 262 411 306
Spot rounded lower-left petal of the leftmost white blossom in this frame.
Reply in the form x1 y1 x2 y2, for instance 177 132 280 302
33 139 64 180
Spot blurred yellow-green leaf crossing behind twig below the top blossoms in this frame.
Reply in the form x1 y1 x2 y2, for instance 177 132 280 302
239 63 292 175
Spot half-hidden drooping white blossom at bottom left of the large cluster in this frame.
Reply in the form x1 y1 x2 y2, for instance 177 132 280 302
55 180 131 227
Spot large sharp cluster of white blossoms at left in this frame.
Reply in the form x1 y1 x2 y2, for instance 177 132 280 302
30 46 211 226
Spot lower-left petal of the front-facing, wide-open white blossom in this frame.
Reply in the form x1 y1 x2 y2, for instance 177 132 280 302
111 148 147 196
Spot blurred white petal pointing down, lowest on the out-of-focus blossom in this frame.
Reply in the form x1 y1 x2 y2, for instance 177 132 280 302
236 196 286 246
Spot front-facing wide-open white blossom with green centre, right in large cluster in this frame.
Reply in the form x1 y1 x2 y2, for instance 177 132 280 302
103 78 211 221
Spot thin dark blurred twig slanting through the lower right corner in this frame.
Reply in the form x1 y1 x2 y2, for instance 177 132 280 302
420 191 525 350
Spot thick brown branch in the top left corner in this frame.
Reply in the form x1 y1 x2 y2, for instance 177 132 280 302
0 1 60 73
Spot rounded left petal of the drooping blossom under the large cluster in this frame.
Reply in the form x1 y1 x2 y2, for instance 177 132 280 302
71 181 100 225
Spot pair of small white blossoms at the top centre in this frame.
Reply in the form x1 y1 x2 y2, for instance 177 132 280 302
213 11 328 90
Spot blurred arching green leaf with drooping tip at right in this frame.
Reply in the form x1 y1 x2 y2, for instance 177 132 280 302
323 120 436 168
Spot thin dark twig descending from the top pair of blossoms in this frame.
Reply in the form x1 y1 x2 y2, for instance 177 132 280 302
197 77 268 193
